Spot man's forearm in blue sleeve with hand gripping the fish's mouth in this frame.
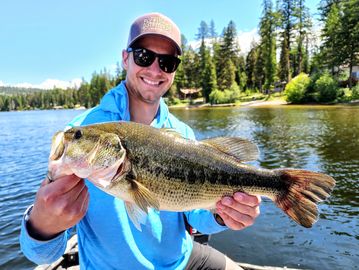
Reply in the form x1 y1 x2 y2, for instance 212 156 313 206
20 175 89 264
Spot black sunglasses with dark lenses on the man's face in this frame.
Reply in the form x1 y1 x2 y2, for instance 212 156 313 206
127 48 181 73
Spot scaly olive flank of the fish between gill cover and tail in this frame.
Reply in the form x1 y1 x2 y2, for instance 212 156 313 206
105 123 285 210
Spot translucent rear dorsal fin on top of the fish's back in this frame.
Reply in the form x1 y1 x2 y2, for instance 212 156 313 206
201 137 259 162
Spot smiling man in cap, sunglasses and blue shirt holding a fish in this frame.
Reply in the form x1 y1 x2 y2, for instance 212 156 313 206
20 13 260 269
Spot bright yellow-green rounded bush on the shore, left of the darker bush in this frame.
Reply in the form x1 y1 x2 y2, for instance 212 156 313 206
284 73 310 103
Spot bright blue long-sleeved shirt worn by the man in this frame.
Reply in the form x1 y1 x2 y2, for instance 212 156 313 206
20 82 227 269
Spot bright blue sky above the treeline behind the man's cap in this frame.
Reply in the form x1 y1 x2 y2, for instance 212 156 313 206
0 0 320 88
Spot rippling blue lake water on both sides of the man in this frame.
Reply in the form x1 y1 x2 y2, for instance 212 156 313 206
0 106 359 269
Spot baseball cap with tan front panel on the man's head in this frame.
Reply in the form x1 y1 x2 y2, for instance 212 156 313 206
127 13 182 55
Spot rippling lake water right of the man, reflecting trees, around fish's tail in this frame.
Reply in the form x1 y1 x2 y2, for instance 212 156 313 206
173 106 359 269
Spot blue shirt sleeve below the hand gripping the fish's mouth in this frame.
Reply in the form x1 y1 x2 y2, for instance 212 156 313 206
20 208 70 264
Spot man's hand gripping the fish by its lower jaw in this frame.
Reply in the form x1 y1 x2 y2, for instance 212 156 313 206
27 175 89 240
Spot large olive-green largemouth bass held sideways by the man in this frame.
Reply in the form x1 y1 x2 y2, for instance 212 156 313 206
48 122 335 228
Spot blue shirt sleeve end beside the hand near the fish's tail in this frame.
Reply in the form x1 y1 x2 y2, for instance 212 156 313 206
184 209 228 234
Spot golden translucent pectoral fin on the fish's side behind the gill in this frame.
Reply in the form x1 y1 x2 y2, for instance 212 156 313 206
130 180 160 213
